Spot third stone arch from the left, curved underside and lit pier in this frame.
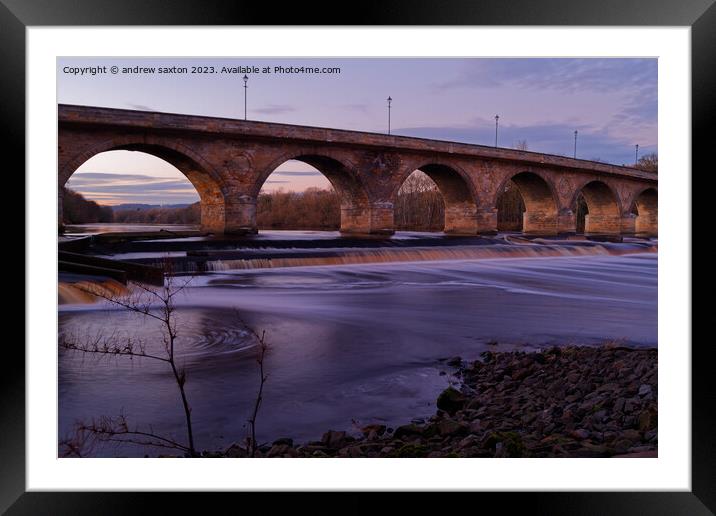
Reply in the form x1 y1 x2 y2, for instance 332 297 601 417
392 159 477 235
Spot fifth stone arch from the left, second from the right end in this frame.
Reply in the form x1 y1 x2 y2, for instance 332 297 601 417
571 180 622 235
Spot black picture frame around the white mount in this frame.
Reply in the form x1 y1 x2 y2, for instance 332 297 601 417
0 0 716 515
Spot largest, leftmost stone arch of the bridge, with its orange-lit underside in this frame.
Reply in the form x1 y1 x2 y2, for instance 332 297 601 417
58 135 226 233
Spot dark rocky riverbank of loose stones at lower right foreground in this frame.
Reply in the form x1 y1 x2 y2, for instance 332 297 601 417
211 343 658 457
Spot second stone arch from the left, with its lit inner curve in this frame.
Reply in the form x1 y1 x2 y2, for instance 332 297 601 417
251 151 372 234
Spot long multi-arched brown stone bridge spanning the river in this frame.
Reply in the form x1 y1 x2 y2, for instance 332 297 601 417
58 105 657 235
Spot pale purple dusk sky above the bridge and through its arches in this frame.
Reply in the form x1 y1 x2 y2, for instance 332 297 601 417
57 58 658 205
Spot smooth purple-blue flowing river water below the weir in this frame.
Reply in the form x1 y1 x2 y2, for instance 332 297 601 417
59 236 657 456
